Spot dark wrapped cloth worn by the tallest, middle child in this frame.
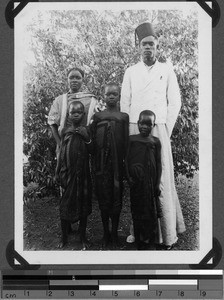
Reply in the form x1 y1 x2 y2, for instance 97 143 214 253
91 111 129 214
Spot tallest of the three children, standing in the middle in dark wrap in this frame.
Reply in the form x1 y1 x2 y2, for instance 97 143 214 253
91 83 129 248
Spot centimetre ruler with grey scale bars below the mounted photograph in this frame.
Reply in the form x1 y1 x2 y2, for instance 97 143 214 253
1 270 223 299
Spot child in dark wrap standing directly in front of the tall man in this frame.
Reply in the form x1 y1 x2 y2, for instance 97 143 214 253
126 110 162 250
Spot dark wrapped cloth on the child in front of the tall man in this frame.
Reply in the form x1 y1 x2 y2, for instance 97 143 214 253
127 135 161 240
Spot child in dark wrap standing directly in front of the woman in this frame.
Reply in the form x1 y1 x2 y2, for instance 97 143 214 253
56 101 92 249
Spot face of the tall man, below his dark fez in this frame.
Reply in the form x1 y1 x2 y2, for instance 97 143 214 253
139 35 158 63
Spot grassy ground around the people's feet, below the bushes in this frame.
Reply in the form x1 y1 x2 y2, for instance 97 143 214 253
24 174 199 250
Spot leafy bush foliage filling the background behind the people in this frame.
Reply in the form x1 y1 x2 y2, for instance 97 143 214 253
23 10 198 195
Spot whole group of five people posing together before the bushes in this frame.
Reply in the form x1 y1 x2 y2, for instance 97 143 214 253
48 23 185 250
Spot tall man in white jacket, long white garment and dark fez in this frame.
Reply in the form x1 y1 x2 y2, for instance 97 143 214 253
120 23 185 249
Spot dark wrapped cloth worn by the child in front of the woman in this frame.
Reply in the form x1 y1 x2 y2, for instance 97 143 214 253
59 127 92 222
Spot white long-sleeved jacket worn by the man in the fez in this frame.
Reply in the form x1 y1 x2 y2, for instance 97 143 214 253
120 61 181 136
